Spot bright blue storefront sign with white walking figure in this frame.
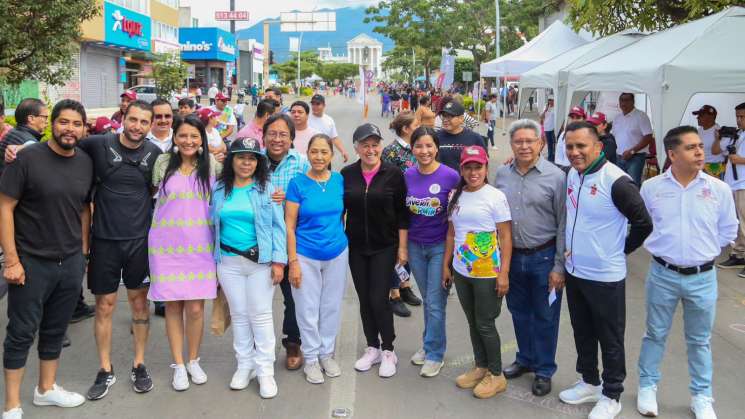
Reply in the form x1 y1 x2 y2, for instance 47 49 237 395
104 2 151 51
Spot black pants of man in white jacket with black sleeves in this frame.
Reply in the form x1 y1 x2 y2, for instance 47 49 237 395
566 273 626 400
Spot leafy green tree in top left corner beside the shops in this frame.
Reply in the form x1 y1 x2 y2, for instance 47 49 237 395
0 0 100 86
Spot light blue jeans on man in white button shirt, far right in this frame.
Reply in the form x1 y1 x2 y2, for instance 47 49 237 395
639 261 717 397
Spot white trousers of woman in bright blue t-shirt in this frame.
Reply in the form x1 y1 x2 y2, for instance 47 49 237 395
292 249 349 363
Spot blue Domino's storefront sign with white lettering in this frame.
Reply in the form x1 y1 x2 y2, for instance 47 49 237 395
179 28 236 61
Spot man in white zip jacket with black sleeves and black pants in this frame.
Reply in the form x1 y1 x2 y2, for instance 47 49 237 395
559 121 652 419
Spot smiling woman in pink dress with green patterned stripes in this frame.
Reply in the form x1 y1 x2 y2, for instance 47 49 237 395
148 116 218 391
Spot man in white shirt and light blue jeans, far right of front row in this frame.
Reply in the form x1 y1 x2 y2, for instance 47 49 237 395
637 126 738 419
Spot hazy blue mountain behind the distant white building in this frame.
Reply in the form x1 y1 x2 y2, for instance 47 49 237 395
236 7 394 63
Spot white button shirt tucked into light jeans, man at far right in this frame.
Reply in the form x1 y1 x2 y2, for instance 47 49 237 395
641 169 738 267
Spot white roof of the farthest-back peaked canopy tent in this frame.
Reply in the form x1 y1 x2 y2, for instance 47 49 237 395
481 20 587 77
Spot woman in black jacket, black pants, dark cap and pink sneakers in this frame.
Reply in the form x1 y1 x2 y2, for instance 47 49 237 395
341 124 409 377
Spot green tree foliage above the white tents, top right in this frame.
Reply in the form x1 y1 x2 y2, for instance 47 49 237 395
567 0 742 36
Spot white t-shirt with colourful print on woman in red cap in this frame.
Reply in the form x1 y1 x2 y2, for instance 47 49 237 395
450 185 512 278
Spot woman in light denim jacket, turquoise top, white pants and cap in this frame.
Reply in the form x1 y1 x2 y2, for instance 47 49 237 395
210 138 287 398
